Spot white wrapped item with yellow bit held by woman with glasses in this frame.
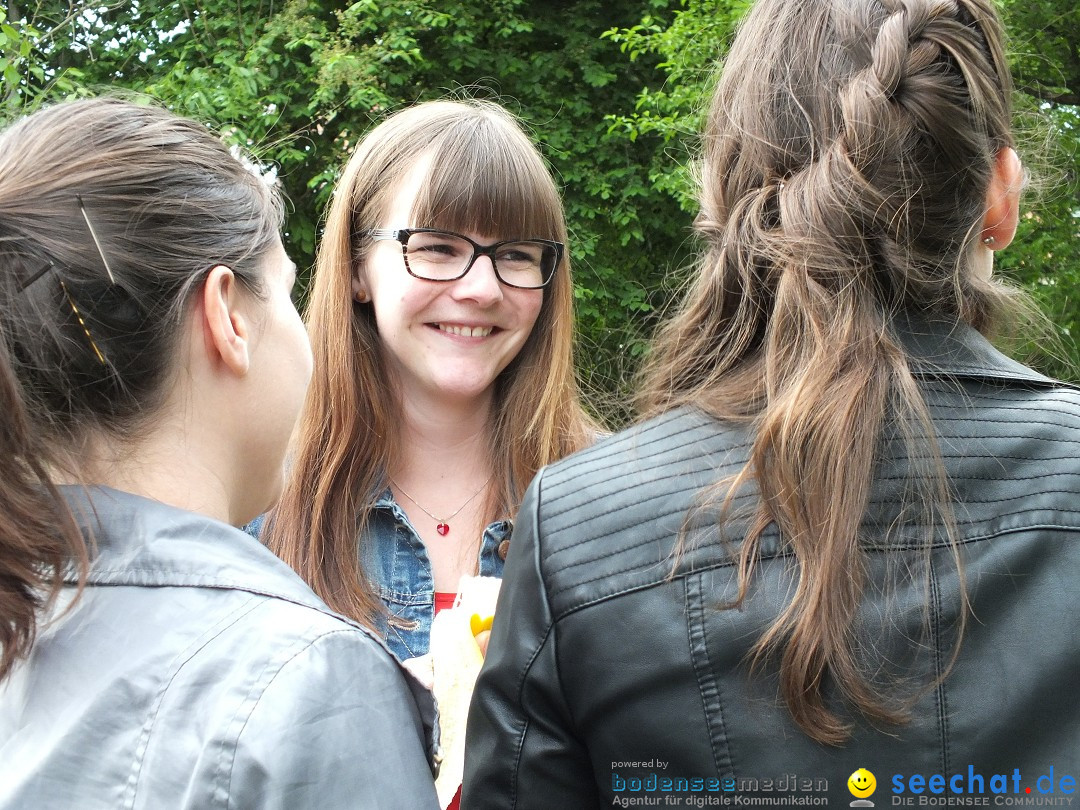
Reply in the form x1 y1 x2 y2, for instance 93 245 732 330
425 577 500 808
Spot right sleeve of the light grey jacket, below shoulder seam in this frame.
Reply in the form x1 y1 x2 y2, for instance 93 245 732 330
229 629 438 810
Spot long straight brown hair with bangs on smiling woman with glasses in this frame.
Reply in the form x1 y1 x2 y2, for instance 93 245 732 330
265 100 595 624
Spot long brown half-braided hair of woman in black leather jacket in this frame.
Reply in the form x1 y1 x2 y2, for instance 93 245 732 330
639 0 1032 744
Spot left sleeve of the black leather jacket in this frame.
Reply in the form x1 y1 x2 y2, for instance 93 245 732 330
461 471 599 810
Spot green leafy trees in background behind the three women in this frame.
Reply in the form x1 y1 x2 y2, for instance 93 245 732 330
0 0 1080 423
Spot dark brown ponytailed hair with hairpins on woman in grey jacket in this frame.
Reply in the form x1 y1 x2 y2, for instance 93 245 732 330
0 98 282 679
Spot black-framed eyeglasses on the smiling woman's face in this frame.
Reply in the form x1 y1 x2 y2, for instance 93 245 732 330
367 228 565 289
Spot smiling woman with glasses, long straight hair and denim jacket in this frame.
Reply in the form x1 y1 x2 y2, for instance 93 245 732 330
262 100 595 807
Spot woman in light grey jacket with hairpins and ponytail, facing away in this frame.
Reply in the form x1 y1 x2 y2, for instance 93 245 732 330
0 99 436 810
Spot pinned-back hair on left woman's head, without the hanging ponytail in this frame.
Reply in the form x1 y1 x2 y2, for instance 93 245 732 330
0 99 281 441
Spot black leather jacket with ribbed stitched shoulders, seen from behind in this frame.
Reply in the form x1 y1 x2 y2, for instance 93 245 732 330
462 324 1080 810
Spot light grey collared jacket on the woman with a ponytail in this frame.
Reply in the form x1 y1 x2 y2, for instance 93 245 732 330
0 488 437 810
